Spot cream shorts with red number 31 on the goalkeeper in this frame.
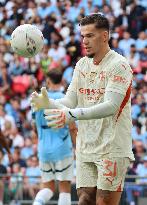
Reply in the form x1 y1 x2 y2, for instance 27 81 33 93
76 158 130 192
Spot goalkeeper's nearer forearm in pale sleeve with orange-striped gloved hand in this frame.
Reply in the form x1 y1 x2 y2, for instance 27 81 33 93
44 92 124 128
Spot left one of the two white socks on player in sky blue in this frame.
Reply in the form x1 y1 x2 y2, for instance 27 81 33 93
33 188 53 205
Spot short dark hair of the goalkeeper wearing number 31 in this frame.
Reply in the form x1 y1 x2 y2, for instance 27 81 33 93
79 13 110 32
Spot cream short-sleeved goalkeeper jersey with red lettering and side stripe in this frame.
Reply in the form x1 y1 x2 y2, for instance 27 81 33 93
67 50 134 161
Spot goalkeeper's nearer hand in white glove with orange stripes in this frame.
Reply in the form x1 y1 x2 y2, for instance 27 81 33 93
44 108 76 129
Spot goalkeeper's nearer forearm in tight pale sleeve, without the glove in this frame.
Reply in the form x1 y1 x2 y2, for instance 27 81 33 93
70 94 124 120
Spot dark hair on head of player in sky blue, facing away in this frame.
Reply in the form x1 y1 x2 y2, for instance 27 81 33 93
47 68 63 84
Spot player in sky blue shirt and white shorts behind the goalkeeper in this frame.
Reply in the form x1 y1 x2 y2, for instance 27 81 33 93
33 69 76 205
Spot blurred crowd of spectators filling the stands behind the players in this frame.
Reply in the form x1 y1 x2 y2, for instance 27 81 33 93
0 0 147 204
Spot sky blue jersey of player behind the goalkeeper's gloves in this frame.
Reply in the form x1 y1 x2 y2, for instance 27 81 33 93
34 91 73 162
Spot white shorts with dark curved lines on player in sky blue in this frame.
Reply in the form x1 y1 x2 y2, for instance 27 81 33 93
39 157 73 182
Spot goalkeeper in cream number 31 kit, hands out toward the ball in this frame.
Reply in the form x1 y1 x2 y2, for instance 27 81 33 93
31 14 134 205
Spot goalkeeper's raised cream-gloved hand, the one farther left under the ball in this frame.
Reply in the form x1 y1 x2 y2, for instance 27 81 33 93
30 87 50 111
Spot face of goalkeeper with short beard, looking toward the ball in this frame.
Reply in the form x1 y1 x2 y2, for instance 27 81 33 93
81 24 107 58
